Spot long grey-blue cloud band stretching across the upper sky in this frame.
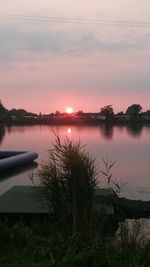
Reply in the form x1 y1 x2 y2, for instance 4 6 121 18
0 23 150 61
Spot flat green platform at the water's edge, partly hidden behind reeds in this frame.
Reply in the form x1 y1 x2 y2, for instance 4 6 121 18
0 186 114 215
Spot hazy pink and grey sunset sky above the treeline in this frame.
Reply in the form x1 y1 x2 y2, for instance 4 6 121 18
0 0 150 113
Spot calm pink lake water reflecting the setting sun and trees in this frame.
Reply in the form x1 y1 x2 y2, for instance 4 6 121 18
0 126 150 200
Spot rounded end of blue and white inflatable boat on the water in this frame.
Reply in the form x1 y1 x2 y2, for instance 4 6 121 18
0 151 38 171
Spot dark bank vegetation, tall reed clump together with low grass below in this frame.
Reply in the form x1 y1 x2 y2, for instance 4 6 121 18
0 136 150 267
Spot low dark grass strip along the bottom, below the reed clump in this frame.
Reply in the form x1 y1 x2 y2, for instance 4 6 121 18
0 221 150 267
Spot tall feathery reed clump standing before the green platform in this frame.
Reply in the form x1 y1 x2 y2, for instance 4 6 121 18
38 135 98 236
